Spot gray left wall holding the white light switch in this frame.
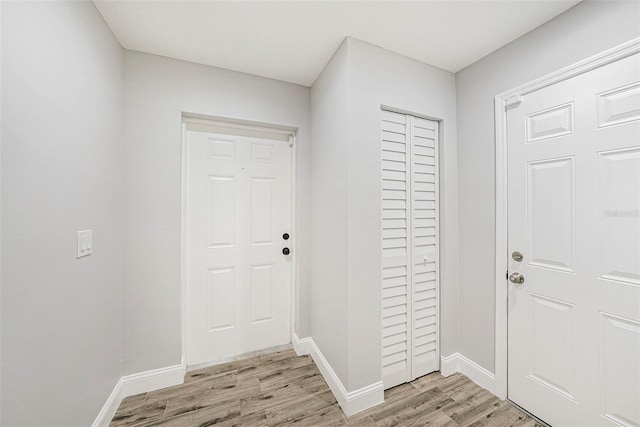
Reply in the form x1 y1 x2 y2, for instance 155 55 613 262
0 2 123 426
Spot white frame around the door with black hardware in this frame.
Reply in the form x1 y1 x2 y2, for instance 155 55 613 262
180 112 298 371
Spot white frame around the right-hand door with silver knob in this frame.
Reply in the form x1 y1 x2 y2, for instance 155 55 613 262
494 38 640 399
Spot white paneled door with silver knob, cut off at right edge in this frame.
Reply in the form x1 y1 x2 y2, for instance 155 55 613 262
507 55 640 426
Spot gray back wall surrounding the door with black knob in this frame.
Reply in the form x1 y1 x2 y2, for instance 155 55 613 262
124 51 310 375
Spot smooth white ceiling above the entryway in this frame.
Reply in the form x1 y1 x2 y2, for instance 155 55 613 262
94 0 579 86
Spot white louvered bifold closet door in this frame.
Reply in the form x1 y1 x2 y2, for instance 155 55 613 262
381 110 440 389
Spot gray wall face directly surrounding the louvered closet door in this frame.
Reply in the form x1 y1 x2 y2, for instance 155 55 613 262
348 39 458 390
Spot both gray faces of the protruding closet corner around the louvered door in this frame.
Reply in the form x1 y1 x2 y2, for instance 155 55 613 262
310 38 458 391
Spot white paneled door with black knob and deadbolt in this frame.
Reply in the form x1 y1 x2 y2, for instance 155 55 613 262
186 126 292 365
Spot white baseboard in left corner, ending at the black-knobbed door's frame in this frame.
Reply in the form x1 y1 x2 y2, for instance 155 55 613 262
92 365 184 427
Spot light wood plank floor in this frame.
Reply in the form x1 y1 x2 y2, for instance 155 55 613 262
111 350 540 427
